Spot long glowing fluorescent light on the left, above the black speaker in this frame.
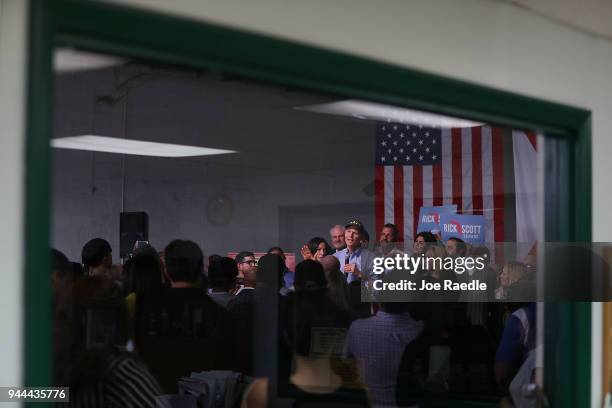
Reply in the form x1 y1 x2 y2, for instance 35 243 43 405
51 135 237 157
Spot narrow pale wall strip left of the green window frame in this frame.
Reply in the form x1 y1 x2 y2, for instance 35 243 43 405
0 0 27 386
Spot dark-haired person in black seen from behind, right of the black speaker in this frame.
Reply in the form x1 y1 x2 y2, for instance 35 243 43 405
134 240 235 393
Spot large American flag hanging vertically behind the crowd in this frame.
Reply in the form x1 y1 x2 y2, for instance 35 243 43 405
375 122 505 242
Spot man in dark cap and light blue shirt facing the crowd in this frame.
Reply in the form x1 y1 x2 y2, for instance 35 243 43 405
333 220 376 283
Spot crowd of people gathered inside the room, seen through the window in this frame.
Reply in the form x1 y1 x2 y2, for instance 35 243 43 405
51 220 536 407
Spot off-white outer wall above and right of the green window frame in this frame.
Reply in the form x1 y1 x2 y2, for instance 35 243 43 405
101 0 612 241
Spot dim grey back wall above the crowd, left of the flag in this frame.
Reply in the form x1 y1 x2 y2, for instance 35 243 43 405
52 64 376 261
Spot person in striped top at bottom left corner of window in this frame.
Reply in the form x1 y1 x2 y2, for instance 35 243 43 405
54 276 163 408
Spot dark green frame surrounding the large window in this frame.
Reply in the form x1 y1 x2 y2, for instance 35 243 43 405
23 0 591 407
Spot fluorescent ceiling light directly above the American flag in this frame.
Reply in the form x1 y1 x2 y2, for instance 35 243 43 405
295 99 483 128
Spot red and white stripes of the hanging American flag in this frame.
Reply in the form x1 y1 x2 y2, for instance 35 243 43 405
376 126 505 242
